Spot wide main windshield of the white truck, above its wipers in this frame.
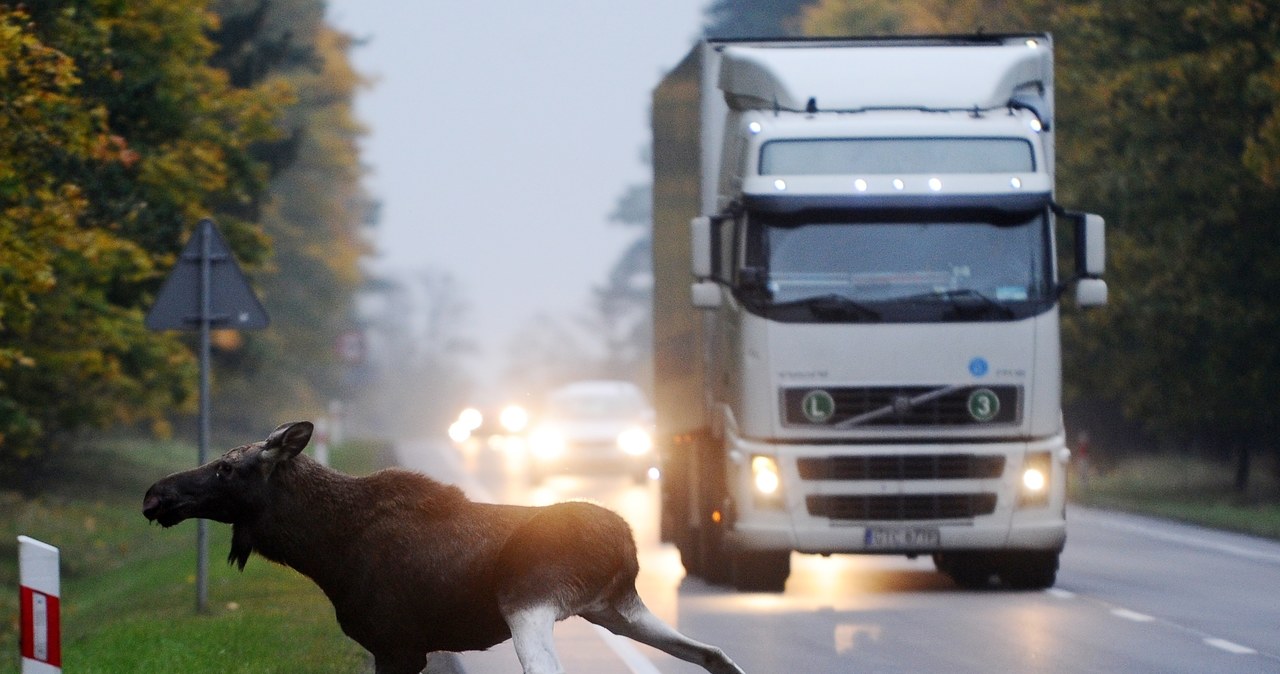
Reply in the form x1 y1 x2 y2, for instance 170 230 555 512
740 211 1055 322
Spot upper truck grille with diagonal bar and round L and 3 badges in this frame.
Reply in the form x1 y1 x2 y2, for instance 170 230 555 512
782 385 1023 428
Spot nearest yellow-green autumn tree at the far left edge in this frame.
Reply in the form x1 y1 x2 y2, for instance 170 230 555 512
0 0 287 476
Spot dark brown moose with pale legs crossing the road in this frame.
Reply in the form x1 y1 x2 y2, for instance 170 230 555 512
142 421 742 674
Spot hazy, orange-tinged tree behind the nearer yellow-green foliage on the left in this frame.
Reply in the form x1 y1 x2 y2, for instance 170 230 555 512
199 0 370 428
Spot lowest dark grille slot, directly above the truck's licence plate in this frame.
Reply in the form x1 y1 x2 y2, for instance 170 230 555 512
805 494 996 522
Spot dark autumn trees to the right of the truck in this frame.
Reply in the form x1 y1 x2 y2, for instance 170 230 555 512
1060 0 1280 487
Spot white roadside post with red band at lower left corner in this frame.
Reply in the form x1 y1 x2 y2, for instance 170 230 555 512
18 536 63 674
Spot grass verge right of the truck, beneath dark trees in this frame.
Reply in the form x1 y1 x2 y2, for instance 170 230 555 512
1070 455 1280 540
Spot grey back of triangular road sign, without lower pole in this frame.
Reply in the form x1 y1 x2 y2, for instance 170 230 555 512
146 219 270 330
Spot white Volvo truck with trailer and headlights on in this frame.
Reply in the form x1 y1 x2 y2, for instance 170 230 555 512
653 33 1107 591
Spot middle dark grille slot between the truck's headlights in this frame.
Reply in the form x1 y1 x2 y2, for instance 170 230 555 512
796 454 1005 480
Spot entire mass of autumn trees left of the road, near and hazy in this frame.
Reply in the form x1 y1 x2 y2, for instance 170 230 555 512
0 0 367 480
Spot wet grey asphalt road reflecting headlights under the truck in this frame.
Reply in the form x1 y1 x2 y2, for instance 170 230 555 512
398 441 1280 674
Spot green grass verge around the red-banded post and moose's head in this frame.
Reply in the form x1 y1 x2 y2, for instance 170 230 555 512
0 441 383 674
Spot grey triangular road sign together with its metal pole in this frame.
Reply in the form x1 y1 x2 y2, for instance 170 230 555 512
146 219 270 613
